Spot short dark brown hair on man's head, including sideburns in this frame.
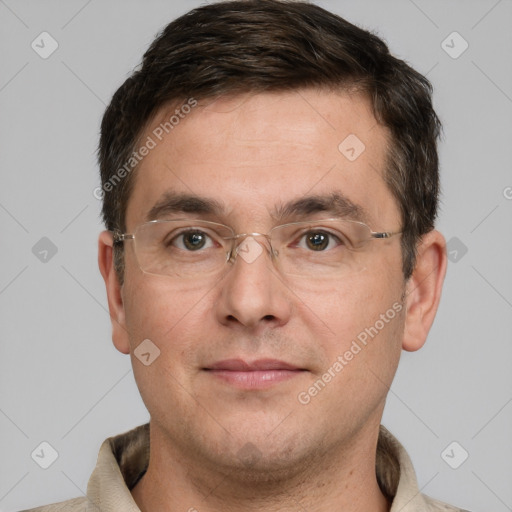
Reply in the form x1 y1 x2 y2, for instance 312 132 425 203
98 0 440 279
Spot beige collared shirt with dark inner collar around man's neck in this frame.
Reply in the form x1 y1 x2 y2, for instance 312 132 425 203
23 424 467 512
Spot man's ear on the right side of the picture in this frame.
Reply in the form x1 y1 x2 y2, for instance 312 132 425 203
402 230 447 352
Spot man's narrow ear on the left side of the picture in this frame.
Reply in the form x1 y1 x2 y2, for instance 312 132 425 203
98 231 130 354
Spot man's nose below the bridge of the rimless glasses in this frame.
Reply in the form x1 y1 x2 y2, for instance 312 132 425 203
216 233 292 335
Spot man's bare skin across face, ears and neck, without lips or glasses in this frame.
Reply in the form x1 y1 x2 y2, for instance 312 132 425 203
99 90 446 512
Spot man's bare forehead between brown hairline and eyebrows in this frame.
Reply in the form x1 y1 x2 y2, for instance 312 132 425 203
126 89 398 229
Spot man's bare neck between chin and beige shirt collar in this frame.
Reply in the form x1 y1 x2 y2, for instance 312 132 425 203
132 424 390 512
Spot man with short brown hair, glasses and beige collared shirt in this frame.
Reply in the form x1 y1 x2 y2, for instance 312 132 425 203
25 0 472 512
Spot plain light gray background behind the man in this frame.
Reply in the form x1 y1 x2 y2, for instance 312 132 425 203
0 0 512 512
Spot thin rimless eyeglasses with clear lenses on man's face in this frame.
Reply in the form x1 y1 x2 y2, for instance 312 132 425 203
113 219 400 279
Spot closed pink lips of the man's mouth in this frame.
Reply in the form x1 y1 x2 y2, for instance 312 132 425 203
203 359 306 390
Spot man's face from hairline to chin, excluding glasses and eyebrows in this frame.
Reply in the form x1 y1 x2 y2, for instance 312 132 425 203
115 90 405 474
